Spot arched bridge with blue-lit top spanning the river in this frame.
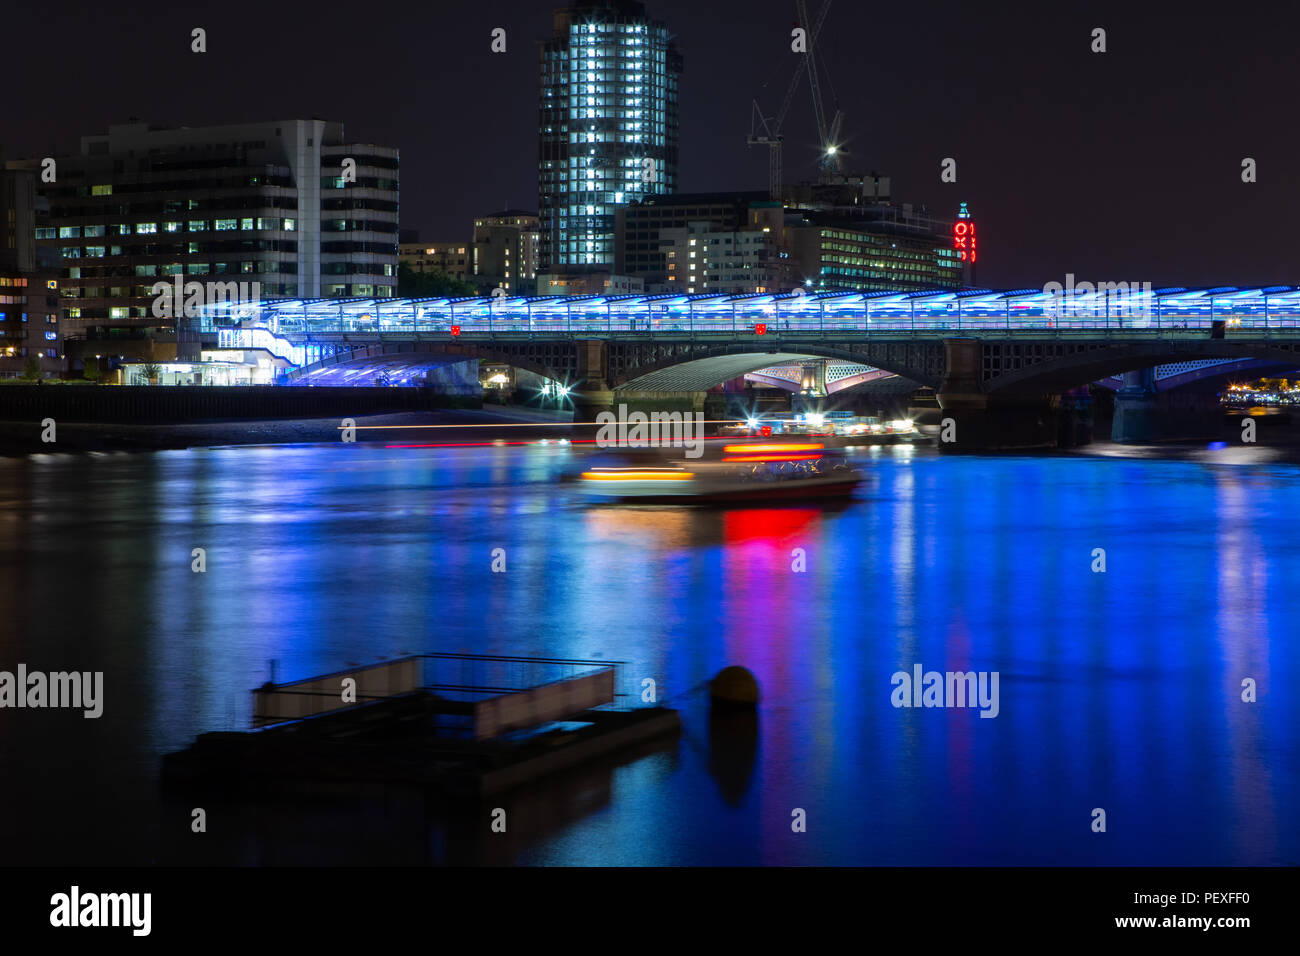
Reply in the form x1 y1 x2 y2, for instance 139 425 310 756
200 285 1300 442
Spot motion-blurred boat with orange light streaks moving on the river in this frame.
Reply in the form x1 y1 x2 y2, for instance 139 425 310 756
580 442 862 503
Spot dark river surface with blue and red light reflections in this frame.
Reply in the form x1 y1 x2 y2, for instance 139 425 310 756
0 444 1300 865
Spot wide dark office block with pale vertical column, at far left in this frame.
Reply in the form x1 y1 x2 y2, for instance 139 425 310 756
9 120 398 359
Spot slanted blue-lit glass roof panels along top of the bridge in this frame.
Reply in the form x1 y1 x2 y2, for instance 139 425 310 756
203 284 1300 319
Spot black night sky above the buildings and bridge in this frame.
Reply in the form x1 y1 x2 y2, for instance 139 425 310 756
0 0 1300 287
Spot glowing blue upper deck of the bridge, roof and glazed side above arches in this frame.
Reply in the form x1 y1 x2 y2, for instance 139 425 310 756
202 286 1300 341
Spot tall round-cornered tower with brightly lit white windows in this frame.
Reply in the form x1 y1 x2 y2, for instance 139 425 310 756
538 0 681 273
